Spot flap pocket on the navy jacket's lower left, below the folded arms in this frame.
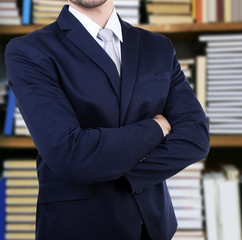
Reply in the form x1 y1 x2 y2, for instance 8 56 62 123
38 179 94 203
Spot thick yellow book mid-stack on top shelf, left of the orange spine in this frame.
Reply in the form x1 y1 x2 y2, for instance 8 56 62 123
146 3 191 14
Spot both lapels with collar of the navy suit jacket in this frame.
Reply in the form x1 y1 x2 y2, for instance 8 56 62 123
56 5 139 126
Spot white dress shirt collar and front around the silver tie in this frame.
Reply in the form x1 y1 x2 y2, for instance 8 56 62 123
69 6 123 64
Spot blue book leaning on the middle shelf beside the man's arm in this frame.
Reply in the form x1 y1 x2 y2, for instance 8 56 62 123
3 89 15 135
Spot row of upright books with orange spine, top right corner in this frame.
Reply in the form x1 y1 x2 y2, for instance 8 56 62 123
195 0 242 23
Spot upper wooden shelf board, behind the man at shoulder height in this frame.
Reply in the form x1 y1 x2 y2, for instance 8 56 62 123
0 22 242 35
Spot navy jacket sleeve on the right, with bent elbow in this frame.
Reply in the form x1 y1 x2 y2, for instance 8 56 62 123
119 40 210 193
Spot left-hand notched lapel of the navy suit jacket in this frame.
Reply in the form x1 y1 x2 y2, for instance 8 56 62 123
57 5 120 102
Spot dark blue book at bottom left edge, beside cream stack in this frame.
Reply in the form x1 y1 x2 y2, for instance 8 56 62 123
0 178 5 240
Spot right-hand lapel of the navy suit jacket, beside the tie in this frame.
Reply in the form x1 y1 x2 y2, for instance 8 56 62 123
119 18 139 126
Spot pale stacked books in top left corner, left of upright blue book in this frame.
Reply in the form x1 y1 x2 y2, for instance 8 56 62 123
0 0 21 25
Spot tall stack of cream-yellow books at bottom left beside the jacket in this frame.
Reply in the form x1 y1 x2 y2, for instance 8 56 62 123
3 159 38 240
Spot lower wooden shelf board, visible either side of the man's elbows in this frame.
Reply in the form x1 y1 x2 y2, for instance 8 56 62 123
0 135 242 148
